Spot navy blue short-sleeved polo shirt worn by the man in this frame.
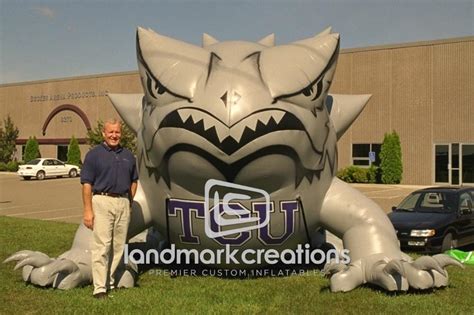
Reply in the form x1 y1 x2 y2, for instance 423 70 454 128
81 142 138 194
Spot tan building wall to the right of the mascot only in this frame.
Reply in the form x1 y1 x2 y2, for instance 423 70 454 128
331 37 474 185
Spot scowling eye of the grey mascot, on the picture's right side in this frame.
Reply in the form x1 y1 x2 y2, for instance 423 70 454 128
277 77 330 113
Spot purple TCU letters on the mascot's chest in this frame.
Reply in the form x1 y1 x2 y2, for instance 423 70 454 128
168 199 299 246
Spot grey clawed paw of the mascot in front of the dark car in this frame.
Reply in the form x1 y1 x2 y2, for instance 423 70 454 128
323 254 464 292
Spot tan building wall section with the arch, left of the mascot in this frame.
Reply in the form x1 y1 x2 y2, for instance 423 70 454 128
0 72 141 159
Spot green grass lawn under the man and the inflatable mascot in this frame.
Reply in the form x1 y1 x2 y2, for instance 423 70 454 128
0 217 474 314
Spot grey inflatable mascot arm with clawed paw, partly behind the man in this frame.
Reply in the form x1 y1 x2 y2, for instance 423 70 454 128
4 185 151 290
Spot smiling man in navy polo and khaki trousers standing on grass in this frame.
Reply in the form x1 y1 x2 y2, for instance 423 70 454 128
81 119 138 298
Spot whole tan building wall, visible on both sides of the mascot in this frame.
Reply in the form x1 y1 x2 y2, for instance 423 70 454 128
0 37 474 185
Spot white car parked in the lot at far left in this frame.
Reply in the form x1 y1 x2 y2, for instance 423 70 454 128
17 158 81 180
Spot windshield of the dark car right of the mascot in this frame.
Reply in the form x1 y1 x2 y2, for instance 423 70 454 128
397 191 456 212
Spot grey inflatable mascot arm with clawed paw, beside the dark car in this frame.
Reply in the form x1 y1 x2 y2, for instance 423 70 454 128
320 178 462 291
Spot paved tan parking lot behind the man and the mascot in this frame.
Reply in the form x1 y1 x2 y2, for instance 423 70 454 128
0 173 421 223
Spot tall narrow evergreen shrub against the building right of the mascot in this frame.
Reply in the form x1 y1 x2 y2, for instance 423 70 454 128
380 131 403 184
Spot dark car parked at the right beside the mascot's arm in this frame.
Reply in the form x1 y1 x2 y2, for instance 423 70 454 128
388 187 474 253
